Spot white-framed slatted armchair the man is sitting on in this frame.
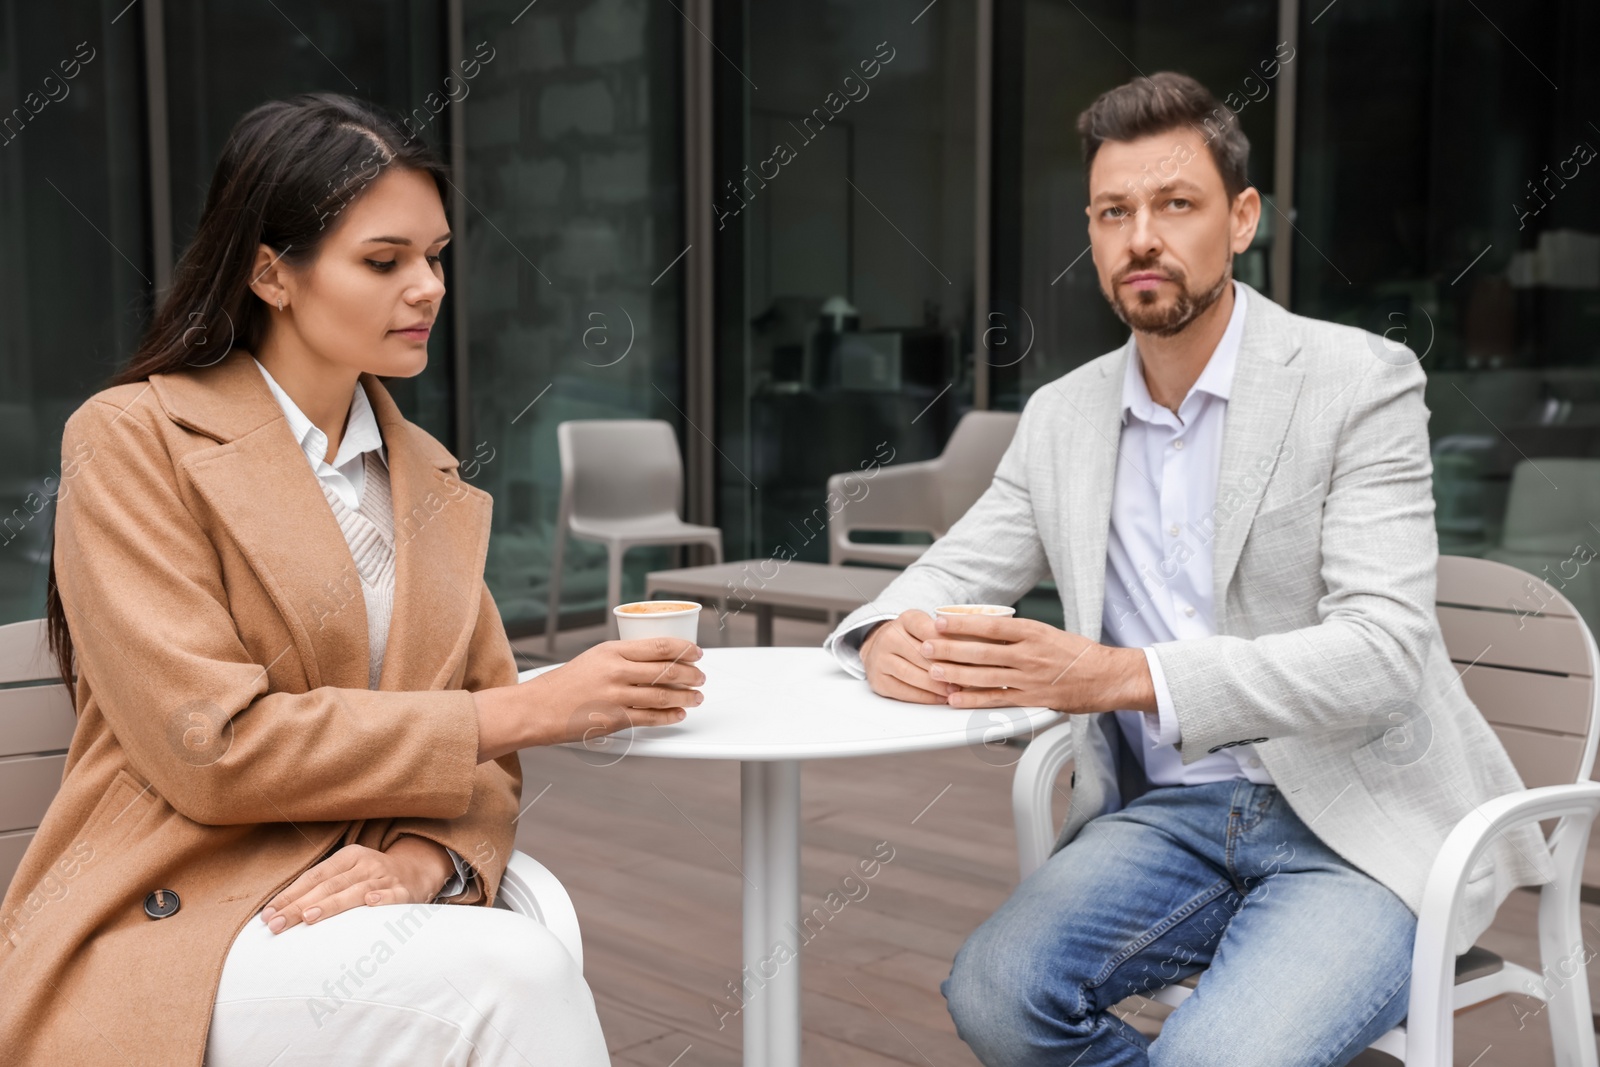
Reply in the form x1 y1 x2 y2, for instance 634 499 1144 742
1011 555 1600 1067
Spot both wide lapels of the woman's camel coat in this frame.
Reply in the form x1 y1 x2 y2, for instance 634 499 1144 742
150 352 491 689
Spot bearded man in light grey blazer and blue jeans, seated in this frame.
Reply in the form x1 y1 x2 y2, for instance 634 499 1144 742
827 74 1554 1067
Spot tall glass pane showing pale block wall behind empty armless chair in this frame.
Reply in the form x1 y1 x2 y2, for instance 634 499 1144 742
462 0 693 632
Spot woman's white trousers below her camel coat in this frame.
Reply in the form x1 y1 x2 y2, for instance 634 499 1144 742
205 904 611 1067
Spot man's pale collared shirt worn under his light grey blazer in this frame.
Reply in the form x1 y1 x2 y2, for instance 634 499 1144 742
1101 282 1272 785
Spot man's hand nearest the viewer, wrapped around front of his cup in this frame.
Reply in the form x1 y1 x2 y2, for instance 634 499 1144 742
921 613 1157 713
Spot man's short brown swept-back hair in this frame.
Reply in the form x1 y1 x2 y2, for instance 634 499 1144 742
1078 70 1250 200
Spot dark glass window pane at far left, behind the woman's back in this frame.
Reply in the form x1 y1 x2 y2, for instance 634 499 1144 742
0 3 152 624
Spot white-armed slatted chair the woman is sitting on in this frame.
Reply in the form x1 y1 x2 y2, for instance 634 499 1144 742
0 619 584 968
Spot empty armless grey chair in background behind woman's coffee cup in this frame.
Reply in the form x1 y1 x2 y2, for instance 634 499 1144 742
544 419 722 653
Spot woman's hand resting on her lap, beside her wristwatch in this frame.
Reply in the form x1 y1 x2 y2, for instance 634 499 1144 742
261 833 456 934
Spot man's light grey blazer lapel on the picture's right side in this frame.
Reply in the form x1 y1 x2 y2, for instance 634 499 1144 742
1211 290 1302 633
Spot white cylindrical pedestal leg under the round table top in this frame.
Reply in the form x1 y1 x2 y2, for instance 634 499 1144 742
739 760 802 1067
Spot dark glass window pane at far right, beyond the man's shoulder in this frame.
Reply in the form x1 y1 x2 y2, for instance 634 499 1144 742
1294 0 1600 625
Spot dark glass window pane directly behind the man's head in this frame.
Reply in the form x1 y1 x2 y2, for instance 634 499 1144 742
990 0 1280 410
